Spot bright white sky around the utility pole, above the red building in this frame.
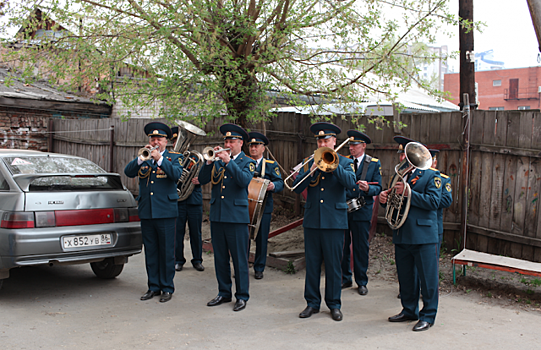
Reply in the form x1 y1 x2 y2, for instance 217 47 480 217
437 0 541 72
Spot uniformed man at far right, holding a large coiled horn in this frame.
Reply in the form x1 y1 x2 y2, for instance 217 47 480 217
380 136 442 332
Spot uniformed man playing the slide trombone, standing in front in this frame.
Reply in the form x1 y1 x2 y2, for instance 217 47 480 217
294 123 357 321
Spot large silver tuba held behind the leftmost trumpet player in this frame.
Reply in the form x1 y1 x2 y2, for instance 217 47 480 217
173 120 207 202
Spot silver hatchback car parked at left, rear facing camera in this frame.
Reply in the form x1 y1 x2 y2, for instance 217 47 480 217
0 149 142 287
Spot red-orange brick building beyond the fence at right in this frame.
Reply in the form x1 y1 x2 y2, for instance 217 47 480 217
444 67 541 110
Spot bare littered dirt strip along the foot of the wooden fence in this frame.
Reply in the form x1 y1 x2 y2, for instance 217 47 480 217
203 208 541 312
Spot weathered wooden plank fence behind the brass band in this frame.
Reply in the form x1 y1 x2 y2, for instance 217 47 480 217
51 110 541 261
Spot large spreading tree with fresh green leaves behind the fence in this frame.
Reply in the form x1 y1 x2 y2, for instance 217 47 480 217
2 0 462 125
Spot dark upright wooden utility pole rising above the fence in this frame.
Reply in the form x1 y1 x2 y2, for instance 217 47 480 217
458 0 477 110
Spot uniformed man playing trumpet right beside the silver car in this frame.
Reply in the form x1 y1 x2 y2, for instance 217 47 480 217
124 122 182 303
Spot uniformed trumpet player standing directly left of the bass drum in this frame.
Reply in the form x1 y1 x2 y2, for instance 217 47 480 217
199 124 255 311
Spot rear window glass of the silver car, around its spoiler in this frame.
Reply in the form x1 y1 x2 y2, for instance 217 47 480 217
4 156 123 192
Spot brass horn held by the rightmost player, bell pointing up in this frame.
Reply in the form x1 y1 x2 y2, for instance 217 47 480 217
385 142 432 230
